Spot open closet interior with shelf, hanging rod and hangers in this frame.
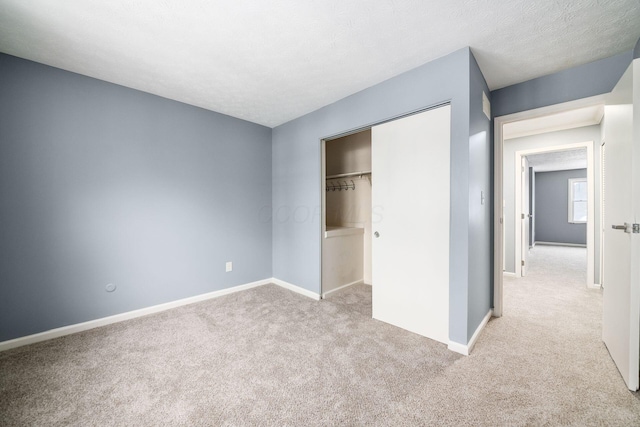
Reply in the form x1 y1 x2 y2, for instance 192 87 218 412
322 130 371 298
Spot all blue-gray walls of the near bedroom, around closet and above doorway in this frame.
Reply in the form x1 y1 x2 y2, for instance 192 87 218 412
0 39 638 343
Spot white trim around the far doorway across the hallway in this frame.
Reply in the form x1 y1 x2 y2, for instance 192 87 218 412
514 141 599 288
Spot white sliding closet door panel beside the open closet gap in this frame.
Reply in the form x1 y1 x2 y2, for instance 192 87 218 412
371 106 451 343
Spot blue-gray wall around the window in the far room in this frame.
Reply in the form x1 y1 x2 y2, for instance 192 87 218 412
535 169 587 245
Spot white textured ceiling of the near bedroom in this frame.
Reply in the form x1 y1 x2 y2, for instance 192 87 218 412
0 0 640 126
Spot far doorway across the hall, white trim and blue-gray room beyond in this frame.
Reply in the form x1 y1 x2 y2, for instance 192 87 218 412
505 143 600 288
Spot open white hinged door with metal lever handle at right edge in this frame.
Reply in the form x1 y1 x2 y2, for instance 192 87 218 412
602 60 640 390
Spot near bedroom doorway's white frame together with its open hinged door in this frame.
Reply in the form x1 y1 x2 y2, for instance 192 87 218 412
494 60 640 391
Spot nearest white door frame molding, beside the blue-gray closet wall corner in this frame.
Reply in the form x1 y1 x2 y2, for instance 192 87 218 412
493 94 607 317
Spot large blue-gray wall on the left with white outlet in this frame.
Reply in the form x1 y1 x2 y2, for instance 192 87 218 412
0 54 272 341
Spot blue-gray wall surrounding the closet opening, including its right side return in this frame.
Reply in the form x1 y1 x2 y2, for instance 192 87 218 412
273 48 491 344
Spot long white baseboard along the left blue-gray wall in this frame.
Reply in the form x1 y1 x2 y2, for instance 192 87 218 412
0 279 274 352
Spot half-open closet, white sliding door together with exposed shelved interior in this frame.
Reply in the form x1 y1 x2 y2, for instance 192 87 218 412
321 104 458 351
